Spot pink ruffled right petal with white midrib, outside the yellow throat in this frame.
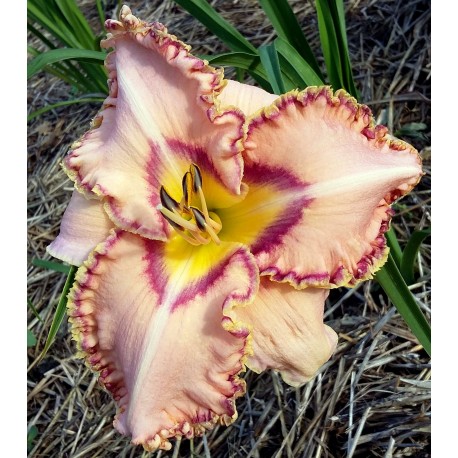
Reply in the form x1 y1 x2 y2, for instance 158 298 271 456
240 87 422 287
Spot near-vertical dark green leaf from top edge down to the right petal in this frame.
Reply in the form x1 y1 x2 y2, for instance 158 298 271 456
315 0 358 98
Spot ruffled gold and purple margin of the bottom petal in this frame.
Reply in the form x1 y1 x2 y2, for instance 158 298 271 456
67 230 259 451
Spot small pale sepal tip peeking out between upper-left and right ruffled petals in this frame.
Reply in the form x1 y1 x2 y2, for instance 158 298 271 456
218 80 278 116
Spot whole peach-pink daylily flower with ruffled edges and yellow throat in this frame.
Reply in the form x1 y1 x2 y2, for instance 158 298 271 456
48 7 422 450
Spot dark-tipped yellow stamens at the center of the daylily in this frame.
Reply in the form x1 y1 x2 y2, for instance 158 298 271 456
158 164 222 245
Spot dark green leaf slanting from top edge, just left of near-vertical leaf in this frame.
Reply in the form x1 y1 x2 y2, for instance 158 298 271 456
259 0 323 79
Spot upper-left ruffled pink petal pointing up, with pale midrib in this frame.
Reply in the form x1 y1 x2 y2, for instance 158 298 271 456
65 7 244 240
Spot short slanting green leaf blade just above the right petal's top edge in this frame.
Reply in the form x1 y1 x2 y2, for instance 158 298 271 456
275 38 324 89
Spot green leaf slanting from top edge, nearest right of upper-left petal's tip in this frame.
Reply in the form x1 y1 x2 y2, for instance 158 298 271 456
175 0 256 54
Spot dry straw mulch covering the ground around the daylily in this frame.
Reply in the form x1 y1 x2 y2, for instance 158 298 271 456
27 0 431 458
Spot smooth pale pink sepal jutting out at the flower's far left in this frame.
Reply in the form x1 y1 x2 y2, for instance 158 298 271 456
46 191 114 266
